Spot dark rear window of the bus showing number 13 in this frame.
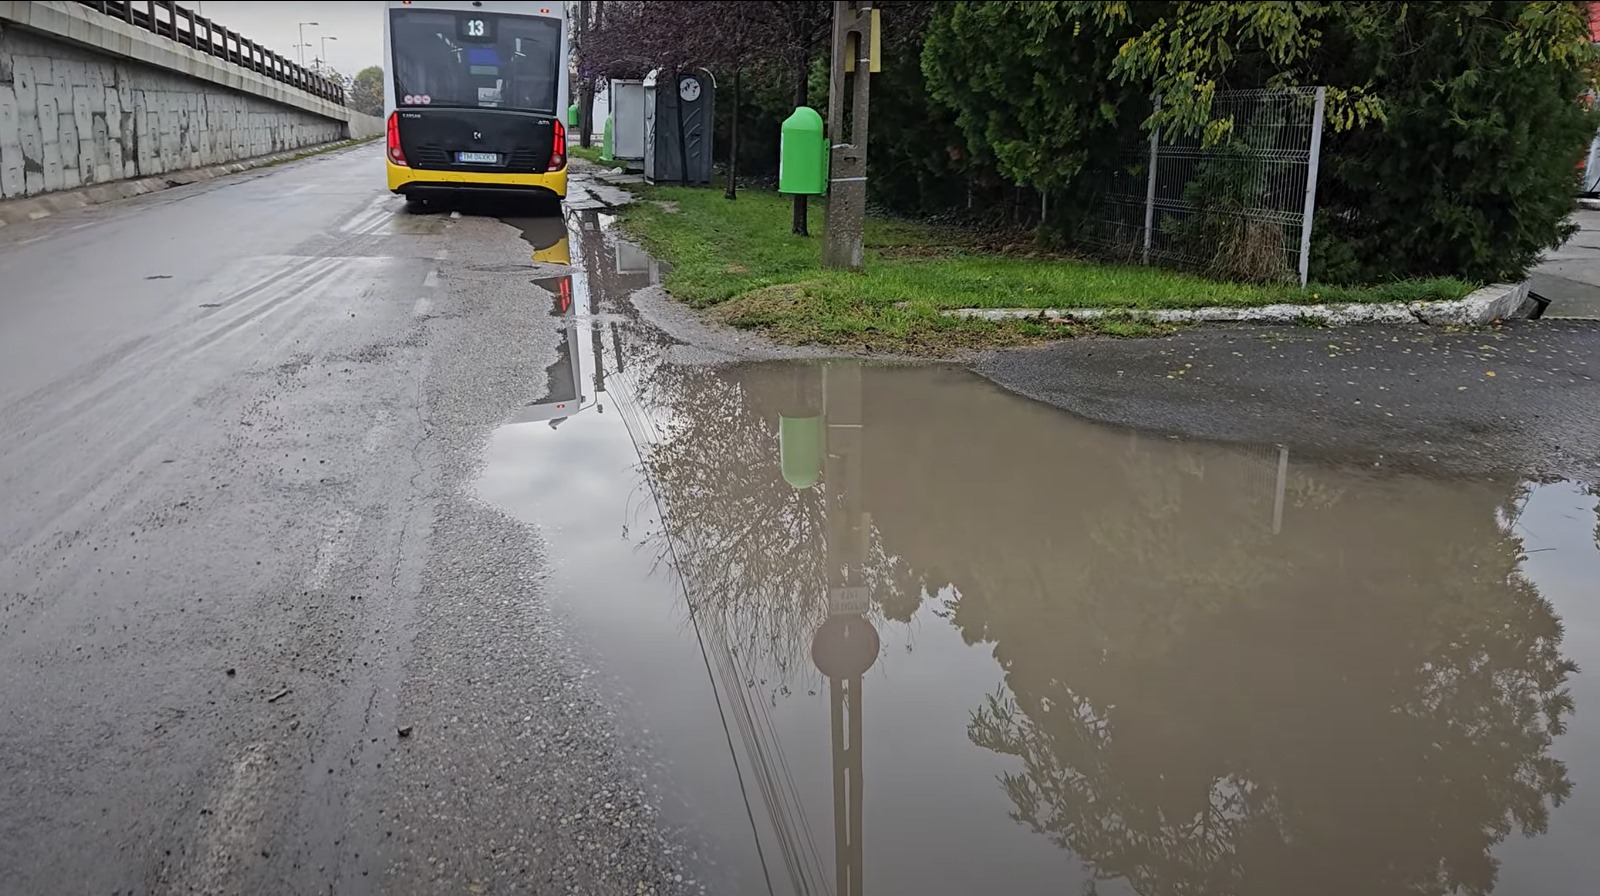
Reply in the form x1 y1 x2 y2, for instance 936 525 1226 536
389 10 562 115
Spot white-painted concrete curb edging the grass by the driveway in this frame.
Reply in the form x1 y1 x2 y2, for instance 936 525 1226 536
944 283 1533 326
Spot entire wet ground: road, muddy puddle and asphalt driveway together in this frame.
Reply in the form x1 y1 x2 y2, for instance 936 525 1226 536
0 147 1600 896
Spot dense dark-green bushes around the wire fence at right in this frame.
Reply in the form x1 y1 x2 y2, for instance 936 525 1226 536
922 0 1597 283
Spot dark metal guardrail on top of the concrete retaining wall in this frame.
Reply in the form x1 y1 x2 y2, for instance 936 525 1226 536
78 0 344 106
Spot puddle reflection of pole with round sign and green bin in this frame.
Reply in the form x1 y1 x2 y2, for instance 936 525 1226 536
779 365 880 896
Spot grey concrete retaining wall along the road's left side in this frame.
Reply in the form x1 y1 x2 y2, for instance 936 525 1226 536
0 2 356 198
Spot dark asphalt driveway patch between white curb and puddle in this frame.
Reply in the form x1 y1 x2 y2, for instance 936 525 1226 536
973 320 1600 480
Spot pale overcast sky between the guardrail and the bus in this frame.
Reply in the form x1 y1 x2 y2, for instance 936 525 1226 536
196 0 384 75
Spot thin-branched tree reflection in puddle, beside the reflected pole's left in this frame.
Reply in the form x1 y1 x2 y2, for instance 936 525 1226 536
645 365 907 684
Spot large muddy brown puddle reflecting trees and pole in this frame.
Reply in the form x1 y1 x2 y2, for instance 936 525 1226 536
480 213 1600 896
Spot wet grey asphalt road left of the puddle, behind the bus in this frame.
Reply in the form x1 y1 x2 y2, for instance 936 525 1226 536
0 146 694 894
